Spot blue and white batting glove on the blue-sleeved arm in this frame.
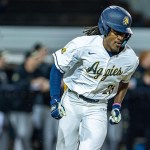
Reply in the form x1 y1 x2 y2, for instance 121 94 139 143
50 98 66 120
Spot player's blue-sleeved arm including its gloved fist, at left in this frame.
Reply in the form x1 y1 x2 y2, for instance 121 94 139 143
50 64 65 119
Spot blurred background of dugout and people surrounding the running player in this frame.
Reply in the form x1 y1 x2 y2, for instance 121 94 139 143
0 0 150 150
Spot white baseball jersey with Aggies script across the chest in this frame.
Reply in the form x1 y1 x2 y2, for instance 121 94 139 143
53 35 139 100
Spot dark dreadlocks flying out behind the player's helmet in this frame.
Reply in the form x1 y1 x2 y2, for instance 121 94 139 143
83 26 101 36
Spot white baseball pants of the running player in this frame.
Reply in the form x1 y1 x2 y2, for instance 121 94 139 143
56 90 107 150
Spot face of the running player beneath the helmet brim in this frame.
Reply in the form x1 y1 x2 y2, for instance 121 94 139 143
103 29 127 52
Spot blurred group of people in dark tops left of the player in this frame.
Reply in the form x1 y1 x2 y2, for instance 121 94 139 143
0 44 58 150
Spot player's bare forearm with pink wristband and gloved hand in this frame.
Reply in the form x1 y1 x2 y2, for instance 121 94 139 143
109 82 129 124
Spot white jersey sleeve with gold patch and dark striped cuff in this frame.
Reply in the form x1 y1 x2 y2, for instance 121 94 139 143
53 39 80 73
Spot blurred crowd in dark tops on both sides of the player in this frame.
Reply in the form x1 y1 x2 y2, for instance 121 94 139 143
0 43 150 150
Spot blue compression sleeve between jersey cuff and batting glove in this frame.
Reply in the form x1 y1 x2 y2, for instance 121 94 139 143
50 64 63 99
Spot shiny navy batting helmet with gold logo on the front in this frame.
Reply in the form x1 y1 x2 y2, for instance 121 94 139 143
98 6 133 36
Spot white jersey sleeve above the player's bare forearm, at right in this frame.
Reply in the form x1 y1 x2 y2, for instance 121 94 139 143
122 58 139 83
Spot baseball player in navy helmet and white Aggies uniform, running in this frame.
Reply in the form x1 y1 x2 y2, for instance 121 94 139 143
50 6 139 150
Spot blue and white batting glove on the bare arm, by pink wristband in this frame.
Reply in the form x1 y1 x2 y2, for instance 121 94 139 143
109 103 121 125
